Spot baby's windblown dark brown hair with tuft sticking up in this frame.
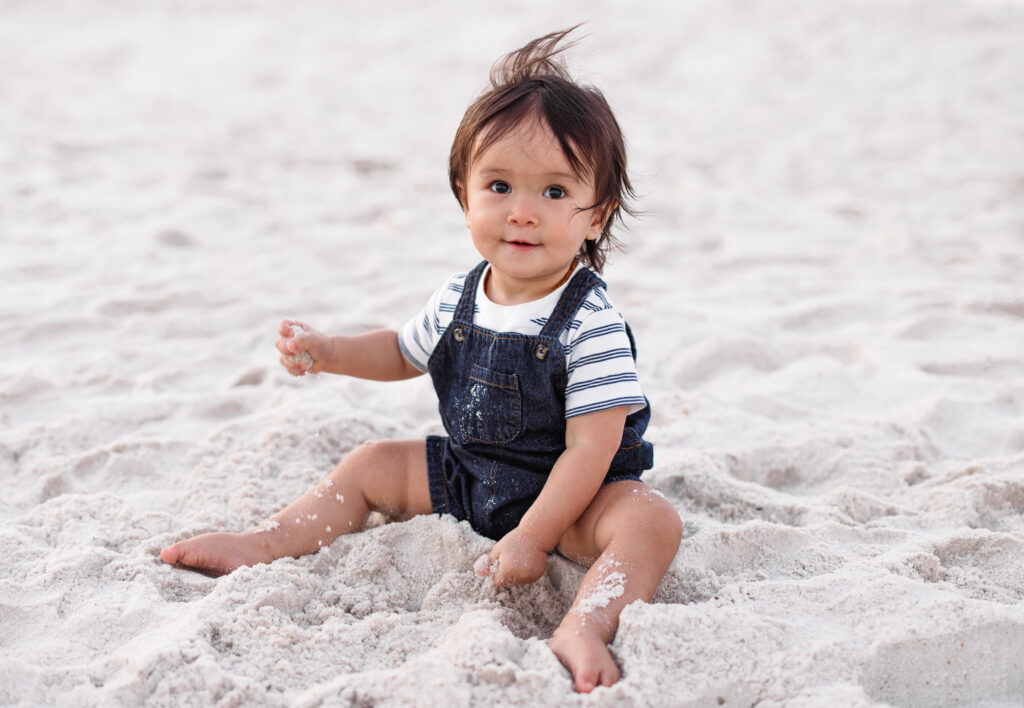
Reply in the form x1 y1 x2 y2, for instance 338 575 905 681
449 25 635 273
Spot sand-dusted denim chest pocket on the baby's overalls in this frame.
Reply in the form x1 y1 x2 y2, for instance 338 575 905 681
449 364 522 445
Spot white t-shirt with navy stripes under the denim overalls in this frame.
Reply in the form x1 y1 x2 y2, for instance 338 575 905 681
398 266 647 418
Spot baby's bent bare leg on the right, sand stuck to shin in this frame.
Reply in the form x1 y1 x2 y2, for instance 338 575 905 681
548 482 682 693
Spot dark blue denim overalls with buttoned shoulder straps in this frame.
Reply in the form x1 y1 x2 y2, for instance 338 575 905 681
427 261 653 540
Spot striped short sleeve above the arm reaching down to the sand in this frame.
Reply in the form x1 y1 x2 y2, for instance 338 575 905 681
565 298 647 418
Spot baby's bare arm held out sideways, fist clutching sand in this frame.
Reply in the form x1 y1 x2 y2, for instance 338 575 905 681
278 320 423 381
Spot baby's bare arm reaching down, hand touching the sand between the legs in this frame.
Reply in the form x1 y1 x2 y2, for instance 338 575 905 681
481 406 629 585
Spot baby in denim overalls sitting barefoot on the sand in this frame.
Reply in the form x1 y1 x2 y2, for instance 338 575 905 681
161 28 682 692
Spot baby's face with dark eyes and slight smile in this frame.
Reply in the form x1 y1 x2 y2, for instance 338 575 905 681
463 121 602 304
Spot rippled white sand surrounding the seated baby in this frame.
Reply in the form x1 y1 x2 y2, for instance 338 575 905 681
0 0 1024 707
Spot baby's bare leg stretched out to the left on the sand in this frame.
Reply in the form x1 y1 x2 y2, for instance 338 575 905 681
160 440 431 573
